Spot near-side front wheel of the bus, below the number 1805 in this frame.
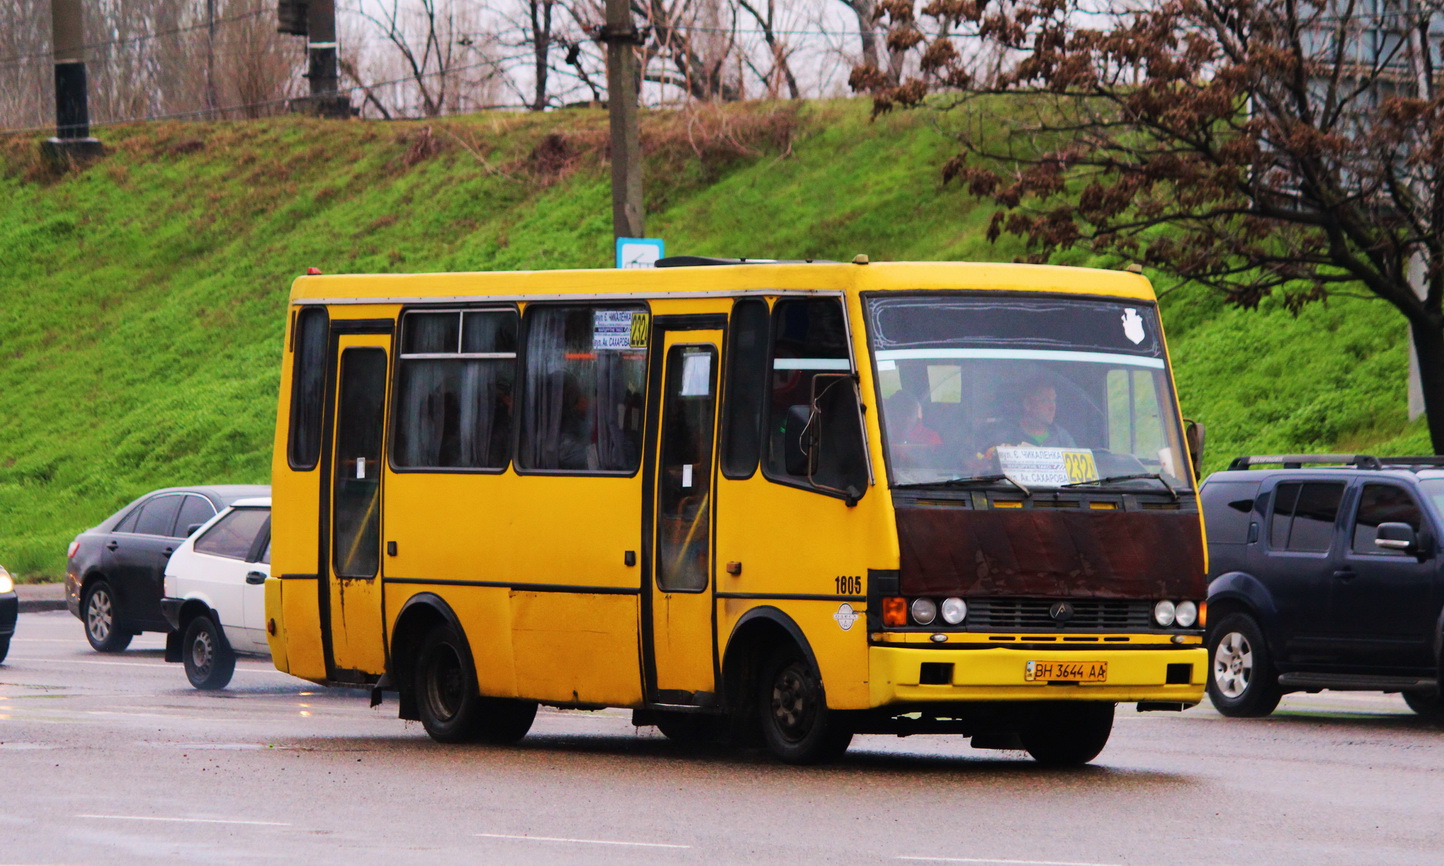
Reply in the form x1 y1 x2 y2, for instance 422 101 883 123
757 645 852 764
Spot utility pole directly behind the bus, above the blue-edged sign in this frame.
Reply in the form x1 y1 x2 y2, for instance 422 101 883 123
601 0 644 238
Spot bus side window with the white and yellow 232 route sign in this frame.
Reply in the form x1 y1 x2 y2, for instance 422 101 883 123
517 305 651 473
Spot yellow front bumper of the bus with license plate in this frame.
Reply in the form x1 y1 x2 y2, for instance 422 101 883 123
868 645 1209 707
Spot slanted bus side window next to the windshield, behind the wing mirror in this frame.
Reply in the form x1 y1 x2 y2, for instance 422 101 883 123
764 299 866 495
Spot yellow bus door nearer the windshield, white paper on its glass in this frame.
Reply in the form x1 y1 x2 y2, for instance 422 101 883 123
644 331 722 706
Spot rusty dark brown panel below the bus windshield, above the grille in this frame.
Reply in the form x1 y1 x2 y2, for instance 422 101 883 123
897 502 1207 599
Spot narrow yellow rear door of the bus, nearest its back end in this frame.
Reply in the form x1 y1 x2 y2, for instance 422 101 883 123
322 333 391 683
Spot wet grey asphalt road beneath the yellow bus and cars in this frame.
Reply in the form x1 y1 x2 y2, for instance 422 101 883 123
0 612 1444 866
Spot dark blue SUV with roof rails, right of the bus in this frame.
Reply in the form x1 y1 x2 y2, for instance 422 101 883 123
1200 455 1444 722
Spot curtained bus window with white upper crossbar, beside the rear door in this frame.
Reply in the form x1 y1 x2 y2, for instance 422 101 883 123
391 310 517 469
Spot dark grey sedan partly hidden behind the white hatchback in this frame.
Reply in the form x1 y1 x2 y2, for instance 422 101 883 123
65 485 270 652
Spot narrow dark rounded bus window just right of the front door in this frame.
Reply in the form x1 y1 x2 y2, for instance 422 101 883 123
722 297 768 478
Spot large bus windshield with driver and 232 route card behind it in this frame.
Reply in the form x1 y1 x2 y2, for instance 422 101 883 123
866 292 1190 495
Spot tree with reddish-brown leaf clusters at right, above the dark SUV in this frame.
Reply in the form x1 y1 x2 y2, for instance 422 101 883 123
855 0 1444 453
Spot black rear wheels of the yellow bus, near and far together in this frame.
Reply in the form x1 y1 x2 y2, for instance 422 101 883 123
412 624 537 743
